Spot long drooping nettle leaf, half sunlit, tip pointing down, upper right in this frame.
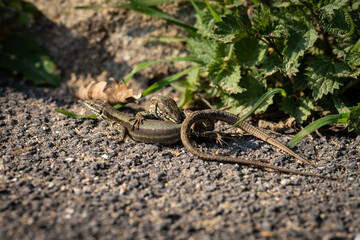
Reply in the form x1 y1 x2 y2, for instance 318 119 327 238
283 28 318 75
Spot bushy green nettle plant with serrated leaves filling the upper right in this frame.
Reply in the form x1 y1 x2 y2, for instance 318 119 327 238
77 0 360 144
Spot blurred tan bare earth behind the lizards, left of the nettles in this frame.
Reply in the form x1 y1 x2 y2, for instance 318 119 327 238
26 0 194 98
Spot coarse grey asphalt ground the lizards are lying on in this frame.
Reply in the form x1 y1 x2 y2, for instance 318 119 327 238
0 72 360 240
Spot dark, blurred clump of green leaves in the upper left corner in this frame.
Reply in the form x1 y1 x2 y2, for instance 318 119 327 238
0 0 60 86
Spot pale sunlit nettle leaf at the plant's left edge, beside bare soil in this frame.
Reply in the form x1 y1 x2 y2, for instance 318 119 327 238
187 38 216 65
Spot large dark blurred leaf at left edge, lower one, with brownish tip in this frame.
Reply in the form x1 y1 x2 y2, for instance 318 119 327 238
0 36 60 86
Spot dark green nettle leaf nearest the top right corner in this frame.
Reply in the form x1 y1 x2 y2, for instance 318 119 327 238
318 8 355 37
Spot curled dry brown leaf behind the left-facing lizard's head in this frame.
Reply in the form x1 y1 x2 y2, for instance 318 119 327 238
76 78 141 104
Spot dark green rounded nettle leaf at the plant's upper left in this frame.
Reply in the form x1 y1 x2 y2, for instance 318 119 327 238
214 14 247 43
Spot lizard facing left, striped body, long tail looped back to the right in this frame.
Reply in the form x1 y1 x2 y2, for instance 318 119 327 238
84 100 333 179
